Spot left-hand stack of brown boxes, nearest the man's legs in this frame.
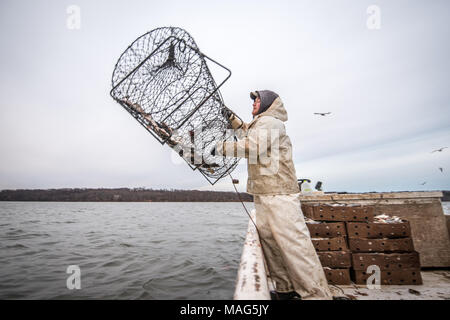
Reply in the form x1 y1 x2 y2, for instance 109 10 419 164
302 204 368 285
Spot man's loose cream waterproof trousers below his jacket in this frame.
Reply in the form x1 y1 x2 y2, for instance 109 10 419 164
254 193 332 300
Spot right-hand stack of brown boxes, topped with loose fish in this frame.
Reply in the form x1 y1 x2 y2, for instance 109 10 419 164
347 216 422 285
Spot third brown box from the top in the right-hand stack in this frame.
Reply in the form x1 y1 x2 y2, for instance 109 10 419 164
352 251 420 271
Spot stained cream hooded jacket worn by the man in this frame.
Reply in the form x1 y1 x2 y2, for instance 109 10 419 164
217 97 300 195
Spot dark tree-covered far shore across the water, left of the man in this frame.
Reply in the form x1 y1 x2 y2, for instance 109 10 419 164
0 188 253 202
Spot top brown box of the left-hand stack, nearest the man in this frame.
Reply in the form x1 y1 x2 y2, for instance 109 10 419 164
309 205 375 222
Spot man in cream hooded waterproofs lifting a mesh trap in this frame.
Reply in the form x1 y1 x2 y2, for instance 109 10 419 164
213 90 332 299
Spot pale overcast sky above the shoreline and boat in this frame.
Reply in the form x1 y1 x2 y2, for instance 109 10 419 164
0 0 450 192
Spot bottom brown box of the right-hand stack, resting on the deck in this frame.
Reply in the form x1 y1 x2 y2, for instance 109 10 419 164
353 268 422 285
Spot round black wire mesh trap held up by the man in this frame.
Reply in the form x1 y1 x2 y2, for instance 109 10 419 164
111 27 238 184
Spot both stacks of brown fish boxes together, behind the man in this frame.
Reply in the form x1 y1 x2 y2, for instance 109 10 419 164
302 204 422 285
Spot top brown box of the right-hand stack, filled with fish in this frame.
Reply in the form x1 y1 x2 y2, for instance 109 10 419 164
346 220 411 238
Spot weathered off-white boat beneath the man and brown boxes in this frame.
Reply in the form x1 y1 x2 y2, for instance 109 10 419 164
234 192 450 300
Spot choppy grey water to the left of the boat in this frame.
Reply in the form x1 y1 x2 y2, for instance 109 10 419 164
0 202 252 299
